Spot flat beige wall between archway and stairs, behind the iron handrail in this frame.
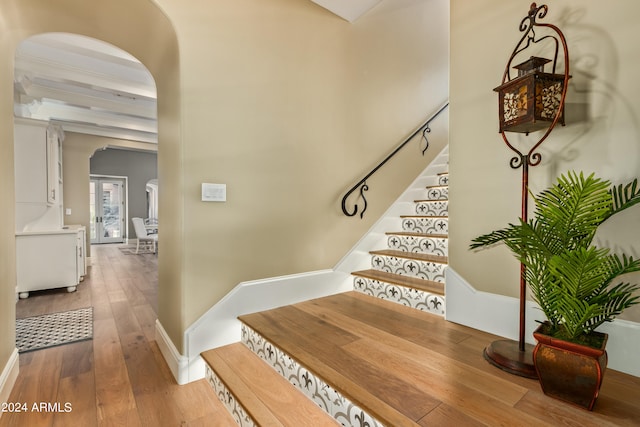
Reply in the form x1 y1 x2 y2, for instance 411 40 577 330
160 0 448 342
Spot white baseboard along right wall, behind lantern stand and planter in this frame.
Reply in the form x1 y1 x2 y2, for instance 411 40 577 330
445 267 640 377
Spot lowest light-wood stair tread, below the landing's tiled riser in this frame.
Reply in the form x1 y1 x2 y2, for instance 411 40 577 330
201 343 338 427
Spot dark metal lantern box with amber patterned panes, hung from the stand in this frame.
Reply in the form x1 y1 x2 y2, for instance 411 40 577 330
494 56 565 134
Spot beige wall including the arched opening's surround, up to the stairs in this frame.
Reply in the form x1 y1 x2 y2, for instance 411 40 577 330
0 0 449 380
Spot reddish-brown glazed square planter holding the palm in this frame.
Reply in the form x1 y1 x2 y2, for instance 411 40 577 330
533 325 608 410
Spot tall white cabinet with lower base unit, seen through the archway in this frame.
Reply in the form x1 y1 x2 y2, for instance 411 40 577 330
14 119 81 298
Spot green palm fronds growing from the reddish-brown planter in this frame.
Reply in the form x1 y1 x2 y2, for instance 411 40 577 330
470 172 640 340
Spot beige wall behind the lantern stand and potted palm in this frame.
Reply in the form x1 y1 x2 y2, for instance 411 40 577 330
450 0 640 321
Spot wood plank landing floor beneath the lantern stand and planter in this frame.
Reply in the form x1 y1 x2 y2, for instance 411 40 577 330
241 292 640 427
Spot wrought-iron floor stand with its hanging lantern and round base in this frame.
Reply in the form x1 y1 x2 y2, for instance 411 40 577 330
484 3 571 378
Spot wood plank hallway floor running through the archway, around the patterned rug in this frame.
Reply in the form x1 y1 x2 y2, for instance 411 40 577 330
0 245 236 427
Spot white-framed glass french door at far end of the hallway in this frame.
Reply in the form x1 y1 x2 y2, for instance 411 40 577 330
89 178 126 244
